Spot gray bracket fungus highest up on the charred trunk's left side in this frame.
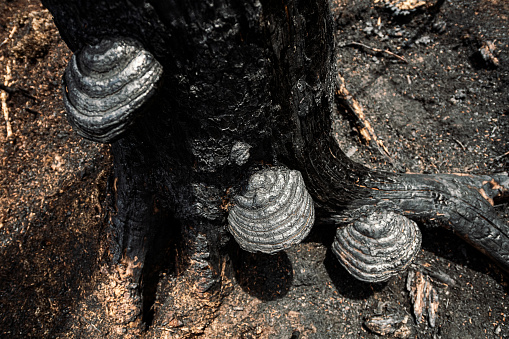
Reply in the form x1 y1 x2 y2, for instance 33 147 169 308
62 38 163 142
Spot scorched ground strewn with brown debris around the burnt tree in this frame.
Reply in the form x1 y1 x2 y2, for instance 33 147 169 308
0 0 509 338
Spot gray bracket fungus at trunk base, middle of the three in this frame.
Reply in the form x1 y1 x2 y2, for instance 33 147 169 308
228 167 315 253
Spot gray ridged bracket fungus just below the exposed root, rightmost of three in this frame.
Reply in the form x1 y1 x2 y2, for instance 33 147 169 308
332 211 422 282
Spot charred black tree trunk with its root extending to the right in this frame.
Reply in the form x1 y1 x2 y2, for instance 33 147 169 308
42 0 509 336
